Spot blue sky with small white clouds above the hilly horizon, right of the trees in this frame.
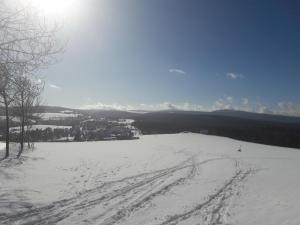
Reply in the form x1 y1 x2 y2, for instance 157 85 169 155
41 0 300 116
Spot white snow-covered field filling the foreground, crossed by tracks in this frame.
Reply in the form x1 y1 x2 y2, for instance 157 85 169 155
0 133 300 225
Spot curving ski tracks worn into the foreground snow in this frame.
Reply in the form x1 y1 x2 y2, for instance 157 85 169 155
0 156 254 225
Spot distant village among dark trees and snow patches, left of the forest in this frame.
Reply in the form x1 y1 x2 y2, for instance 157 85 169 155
0 113 141 143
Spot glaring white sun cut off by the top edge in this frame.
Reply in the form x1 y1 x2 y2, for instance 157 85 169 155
27 0 80 17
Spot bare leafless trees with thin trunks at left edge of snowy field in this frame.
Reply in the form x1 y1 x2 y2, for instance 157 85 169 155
0 1 63 158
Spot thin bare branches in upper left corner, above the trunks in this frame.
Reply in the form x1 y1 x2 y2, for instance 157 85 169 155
0 0 64 69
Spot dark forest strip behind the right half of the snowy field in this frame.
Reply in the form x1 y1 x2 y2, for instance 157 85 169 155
133 113 300 148
